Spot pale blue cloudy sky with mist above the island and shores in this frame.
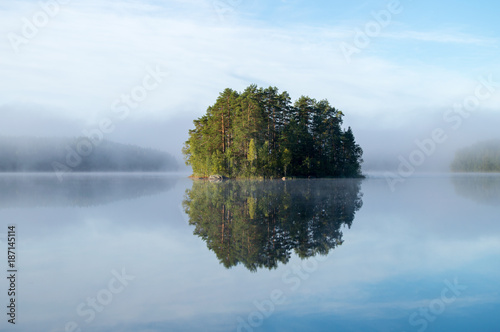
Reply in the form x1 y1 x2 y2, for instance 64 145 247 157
0 0 500 171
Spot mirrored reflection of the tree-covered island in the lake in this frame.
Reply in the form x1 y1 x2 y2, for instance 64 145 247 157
183 179 363 271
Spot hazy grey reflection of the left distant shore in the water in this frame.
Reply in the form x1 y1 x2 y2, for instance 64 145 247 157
0 173 178 209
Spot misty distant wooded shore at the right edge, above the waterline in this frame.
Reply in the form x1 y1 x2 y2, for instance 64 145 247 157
451 140 500 172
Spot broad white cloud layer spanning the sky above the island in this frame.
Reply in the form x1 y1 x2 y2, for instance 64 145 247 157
0 0 494 137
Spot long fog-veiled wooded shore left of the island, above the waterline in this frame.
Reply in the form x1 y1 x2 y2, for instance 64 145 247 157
0 137 178 172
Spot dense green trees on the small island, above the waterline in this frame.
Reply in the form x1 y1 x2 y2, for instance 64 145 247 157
183 85 363 178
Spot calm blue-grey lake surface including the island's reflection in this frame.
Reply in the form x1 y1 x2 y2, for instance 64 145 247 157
0 174 500 332
